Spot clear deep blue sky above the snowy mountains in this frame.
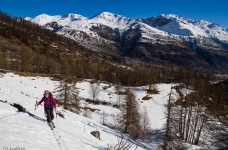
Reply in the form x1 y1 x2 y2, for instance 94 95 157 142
0 0 228 28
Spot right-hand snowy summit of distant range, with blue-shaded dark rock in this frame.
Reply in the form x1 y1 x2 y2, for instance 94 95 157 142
141 14 228 41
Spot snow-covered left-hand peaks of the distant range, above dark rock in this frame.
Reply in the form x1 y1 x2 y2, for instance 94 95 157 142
28 12 135 33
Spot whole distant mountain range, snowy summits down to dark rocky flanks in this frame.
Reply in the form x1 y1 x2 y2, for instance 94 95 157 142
27 12 228 72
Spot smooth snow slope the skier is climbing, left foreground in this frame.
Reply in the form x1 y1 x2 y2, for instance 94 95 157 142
0 73 156 150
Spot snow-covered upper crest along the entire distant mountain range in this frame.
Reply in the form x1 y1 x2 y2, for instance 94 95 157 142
25 12 228 42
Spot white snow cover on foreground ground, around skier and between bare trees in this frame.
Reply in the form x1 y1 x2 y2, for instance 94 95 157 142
0 73 196 150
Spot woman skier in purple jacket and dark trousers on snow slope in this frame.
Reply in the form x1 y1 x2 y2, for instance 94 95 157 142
36 90 56 127
